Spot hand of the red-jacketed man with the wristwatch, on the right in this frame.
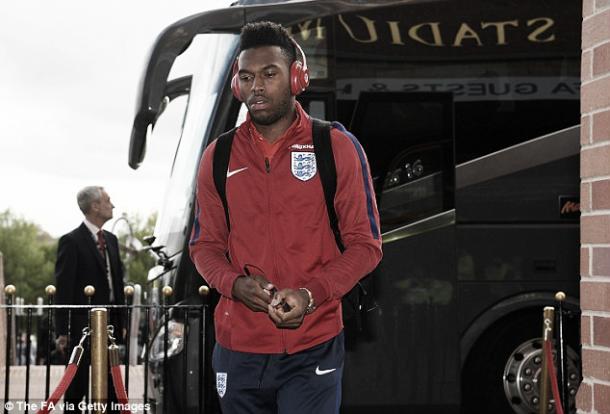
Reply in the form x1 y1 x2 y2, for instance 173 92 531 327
268 289 309 329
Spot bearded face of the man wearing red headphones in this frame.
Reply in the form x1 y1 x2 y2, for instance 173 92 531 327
238 46 294 125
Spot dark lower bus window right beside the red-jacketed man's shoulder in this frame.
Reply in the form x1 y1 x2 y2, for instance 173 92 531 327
350 92 454 232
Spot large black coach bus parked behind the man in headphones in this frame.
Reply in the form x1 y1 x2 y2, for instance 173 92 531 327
129 0 581 414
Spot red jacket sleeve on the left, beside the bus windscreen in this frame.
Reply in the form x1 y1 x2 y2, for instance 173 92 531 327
189 142 241 298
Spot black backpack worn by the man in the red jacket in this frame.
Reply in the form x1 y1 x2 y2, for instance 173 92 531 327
212 118 375 331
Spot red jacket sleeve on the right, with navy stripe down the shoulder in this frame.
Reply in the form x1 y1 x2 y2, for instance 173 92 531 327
305 124 382 306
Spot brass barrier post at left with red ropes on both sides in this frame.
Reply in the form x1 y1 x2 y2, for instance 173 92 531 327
91 308 108 414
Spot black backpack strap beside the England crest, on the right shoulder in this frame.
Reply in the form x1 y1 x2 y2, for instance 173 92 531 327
312 118 345 253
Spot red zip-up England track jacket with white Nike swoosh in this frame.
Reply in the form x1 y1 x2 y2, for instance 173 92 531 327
190 104 381 354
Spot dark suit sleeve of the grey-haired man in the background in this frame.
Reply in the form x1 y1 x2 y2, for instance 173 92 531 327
55 235 78 335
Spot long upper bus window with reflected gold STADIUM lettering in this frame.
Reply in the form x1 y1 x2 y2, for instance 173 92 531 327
329 0 581 164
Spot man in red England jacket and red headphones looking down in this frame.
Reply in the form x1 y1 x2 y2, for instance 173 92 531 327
190 22 381 414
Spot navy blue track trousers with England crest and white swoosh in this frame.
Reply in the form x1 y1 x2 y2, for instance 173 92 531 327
212 332 345 414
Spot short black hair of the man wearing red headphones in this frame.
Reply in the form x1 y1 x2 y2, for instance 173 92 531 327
239 21 297 63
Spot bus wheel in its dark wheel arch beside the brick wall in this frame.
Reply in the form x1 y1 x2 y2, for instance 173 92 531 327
461 310 581 414
